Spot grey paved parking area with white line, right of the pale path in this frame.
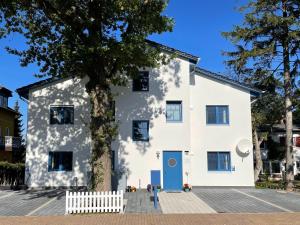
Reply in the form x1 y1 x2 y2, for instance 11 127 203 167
193 188 300 213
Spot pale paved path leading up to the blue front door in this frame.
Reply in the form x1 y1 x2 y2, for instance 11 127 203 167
158 192 216 214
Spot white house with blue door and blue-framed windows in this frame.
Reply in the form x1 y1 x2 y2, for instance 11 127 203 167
17 41 259 190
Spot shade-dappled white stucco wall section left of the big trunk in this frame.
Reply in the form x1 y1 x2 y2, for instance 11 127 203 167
25 79 91 188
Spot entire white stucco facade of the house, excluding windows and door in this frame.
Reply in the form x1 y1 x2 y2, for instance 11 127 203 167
26 53 254 189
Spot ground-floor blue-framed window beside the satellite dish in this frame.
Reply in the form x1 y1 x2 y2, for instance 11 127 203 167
207 152 231 171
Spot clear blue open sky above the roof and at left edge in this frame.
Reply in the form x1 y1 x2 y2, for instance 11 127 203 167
0 0 246 133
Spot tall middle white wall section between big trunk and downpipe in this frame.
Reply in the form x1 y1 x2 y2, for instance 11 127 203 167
113 59 190 188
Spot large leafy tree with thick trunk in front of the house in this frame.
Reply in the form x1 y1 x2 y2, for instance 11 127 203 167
0 0 173 190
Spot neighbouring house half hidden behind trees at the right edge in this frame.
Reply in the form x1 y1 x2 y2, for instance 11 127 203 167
261 124 300 178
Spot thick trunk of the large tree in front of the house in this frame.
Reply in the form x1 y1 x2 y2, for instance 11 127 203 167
87 81 114 191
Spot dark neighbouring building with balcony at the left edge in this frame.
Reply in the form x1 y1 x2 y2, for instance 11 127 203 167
0 86 21 162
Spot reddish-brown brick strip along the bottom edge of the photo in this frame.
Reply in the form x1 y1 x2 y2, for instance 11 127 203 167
0 213 300 225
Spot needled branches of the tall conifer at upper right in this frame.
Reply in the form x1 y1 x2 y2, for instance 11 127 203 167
223 0 300 83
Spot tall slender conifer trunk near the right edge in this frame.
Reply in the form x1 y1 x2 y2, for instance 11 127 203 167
282 0 294 191
